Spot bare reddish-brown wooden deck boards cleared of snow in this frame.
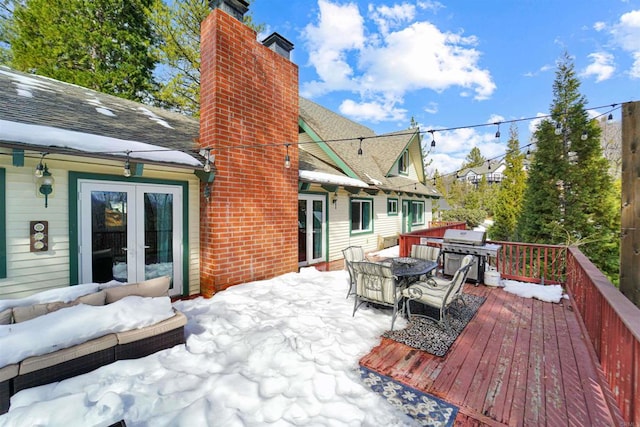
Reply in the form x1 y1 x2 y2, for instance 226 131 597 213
360 284 619 426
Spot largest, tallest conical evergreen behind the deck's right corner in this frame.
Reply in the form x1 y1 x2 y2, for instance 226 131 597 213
518 54 620 280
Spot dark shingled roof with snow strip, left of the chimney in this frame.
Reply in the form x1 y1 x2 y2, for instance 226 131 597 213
0 66 202 167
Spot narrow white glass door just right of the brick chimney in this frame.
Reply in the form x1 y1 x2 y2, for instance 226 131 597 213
298 194 327 266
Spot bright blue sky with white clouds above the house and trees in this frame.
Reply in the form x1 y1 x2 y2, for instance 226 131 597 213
250 0 640 173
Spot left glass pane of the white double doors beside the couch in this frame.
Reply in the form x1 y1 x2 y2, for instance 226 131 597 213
91 191 127 283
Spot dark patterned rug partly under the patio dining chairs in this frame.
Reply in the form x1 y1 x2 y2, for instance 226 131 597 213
382 294 486 356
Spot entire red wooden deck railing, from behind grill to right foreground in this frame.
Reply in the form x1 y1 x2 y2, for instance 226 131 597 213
399 223 640 426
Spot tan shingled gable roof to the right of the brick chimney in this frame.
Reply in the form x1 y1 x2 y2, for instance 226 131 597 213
299 98 439 197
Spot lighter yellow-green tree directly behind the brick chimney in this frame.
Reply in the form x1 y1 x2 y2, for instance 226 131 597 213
153 0 264 117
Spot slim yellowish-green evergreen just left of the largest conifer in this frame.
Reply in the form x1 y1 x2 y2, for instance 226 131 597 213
489 126 527 241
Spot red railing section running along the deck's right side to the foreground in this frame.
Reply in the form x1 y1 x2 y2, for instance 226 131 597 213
565 248 640 426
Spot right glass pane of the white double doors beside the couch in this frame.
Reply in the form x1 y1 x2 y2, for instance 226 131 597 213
144 193 173 280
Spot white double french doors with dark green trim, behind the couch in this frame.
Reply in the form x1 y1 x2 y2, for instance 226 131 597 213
78 180 183 295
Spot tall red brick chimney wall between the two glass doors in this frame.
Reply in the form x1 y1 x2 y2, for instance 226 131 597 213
200 9 298 296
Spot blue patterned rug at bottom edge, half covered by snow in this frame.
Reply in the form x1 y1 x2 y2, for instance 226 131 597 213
360 366 458 427
